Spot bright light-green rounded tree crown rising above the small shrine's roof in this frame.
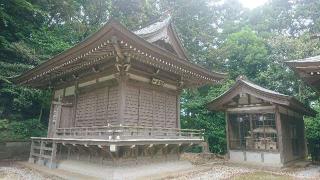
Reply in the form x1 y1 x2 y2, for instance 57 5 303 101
221 27 269 80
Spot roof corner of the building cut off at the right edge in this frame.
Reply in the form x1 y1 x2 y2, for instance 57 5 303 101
285 56 320 92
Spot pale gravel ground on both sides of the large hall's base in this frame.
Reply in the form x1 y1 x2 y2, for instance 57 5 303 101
0 161 320 180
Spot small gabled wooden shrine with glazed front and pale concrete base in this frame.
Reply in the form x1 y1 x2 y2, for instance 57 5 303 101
208 77 315 167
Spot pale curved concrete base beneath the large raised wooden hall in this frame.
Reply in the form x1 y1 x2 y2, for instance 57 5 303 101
58 160 193 179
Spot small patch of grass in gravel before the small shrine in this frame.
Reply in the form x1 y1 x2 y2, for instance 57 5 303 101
231 172 293 180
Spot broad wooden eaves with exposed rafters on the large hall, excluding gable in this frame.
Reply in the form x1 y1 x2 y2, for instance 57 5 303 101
14 20 226 86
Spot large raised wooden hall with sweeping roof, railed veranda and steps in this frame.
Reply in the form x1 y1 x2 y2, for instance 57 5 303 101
15 18 225 168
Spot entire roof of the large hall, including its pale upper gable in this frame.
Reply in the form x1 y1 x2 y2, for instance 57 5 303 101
13 18 226 87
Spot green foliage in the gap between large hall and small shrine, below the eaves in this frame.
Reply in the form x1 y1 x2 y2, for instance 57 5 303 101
181 80 234 154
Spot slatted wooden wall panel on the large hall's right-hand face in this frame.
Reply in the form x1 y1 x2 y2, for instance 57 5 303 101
124 85 178 128
